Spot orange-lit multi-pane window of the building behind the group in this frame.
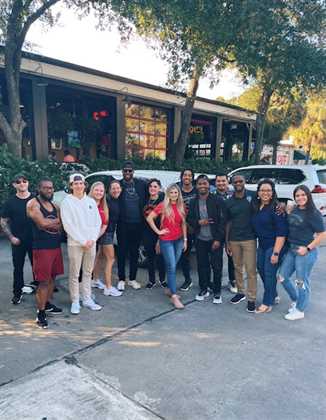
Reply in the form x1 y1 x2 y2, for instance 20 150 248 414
126 104 168 159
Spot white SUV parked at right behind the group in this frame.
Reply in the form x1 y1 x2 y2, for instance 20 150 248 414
229 165 326 216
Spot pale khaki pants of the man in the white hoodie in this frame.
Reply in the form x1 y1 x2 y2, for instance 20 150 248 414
68 245 96 302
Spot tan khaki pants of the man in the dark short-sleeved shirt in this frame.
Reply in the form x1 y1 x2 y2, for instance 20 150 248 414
230 239 257 301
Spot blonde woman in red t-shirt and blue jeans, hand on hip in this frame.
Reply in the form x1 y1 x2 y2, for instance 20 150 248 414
147 184 187 309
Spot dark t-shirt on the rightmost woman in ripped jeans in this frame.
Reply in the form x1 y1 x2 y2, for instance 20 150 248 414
288 207 325 246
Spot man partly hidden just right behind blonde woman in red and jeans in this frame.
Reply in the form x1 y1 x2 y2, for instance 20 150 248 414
178 168 197 292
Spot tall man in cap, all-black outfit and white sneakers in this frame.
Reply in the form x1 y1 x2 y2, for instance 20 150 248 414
117 161 148 290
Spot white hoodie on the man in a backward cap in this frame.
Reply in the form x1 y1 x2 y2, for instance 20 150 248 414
60 194 102 246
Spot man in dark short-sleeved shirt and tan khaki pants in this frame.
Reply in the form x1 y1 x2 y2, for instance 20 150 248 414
225 175 257 312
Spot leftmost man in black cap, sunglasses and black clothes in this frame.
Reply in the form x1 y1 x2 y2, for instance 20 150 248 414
0 175 33 305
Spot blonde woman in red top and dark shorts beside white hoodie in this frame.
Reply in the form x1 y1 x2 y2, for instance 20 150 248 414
89 181 122 296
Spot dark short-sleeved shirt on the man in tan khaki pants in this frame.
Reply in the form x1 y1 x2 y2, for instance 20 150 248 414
225 191 255 241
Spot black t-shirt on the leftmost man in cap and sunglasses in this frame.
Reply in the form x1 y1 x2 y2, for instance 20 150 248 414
1 194 34 242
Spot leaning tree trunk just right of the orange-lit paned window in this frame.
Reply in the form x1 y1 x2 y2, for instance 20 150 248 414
172 69 200 165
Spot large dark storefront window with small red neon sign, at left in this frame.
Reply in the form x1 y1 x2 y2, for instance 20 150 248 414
47 86 116 160
